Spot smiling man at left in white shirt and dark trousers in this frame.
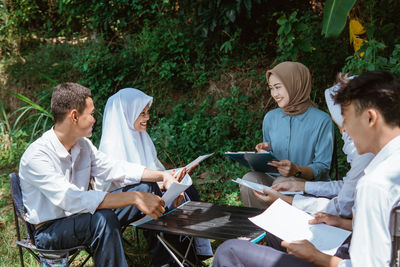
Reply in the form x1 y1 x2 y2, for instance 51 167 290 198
19 83 178 266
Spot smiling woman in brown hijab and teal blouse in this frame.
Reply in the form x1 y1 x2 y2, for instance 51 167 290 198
240 61 334 208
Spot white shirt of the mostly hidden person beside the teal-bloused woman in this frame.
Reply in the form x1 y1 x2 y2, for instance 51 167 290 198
292 153 374 218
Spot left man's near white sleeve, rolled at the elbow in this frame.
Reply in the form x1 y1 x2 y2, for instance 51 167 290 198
20 152 107 214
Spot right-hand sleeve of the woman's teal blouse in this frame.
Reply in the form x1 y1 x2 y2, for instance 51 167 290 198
308 117 334 181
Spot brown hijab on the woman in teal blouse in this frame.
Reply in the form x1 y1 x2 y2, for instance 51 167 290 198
266 61 315 116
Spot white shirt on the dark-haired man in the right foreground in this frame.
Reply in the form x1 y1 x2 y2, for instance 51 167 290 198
339 136 400 267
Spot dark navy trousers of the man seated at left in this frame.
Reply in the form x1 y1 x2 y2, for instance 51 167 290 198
34 183 161 267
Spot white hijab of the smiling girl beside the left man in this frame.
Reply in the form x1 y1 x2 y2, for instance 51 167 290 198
96 88 165 191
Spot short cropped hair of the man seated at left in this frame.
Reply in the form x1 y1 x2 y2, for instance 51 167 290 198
51 83 92 123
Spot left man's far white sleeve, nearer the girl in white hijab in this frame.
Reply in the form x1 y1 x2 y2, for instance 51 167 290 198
89 142 145 185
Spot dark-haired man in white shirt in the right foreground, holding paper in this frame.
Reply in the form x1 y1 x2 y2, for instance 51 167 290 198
213 71 400 267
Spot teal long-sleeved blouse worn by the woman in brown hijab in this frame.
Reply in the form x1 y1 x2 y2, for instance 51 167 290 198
263 107 334 181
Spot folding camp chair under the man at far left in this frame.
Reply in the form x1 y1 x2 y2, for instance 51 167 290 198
10 173 92 266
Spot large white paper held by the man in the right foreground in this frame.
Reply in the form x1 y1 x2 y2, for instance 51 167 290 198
249 199 351 255
